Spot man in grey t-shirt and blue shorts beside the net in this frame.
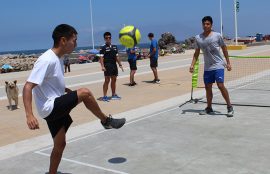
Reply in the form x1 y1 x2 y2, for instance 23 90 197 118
189 16 234 117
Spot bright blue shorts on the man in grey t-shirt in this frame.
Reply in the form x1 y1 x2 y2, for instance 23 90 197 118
203 69 224 84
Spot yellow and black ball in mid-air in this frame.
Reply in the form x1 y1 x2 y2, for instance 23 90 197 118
119 25 141 48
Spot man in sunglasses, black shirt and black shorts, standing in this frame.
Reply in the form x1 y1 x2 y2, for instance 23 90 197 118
100 32 124 102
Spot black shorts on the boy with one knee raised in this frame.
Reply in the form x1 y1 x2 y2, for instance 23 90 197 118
44 91 78 138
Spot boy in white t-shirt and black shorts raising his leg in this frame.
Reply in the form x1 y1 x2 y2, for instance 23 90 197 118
23 24 126 174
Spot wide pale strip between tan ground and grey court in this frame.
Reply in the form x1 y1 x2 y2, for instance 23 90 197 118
0 90 204 160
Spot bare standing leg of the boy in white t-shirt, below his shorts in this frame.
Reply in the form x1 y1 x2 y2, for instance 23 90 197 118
49 127 66 174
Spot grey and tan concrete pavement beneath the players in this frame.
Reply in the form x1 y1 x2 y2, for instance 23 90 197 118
0 46 270 174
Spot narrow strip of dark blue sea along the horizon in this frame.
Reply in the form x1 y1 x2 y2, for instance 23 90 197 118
0 43 149 55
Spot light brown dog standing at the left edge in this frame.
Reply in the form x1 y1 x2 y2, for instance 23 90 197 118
5 80 20 110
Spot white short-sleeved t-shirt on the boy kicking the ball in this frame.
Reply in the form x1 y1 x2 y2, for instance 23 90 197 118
27 49 65 118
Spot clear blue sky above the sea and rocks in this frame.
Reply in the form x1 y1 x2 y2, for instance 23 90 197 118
0 0 270 52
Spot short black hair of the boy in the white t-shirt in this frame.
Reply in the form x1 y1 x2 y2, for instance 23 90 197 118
52 24 78 46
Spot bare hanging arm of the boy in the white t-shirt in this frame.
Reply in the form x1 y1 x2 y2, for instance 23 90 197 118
23 82 39 130
